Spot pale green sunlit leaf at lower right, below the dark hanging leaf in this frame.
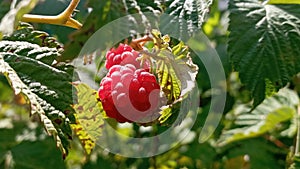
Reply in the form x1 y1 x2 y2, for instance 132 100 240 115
218 89 299 145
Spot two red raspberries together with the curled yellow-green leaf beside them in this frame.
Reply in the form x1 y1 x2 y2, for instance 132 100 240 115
98 34 198 123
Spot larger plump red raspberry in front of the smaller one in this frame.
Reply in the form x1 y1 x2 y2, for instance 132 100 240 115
98 64 160 123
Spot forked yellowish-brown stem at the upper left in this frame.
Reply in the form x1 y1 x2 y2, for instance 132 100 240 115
21 0 82 29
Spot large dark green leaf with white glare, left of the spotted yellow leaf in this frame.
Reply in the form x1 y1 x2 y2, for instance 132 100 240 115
3 53 74 152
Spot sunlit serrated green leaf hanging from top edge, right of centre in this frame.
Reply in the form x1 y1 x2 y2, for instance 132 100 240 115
161 0 212 39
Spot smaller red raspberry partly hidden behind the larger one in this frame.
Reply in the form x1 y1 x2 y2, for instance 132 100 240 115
105 43 149 70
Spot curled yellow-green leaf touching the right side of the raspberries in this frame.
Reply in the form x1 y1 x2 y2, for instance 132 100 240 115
154 40 198 103
